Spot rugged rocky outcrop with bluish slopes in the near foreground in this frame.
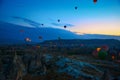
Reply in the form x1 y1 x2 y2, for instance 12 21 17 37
0 54 119 80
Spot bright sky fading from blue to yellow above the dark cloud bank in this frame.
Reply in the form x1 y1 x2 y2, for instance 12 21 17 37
0 0 120 36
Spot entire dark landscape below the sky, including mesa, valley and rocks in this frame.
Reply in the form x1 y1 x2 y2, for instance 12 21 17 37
0 40 120 80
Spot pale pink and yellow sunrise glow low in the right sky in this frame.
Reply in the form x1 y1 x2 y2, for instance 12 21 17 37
70 20 120 36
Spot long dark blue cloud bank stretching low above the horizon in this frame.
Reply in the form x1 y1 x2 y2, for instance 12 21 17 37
0 22 120 45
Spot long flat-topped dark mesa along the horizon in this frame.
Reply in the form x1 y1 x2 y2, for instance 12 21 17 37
42 39 120 47
